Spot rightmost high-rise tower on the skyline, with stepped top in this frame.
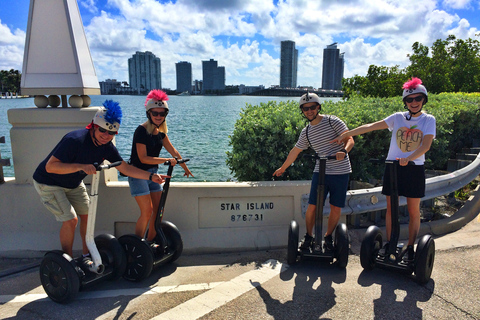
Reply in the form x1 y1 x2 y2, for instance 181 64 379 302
322 42 345 90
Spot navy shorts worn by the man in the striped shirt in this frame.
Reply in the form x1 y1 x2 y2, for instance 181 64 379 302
308 172 350 208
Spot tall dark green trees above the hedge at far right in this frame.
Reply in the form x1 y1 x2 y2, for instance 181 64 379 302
342 35 480 98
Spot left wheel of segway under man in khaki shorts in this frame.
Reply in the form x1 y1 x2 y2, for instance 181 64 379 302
40 251 80 303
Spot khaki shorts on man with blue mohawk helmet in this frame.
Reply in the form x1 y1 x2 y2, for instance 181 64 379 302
33 180 90 222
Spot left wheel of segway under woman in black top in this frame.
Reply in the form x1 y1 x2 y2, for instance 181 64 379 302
118 235 153 281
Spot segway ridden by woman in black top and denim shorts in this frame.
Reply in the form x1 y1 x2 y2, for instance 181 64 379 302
118 159 190 281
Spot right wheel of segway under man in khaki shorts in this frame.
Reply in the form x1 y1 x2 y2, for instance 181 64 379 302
95 234 127 280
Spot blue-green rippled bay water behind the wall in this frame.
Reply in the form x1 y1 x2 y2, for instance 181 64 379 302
0 95 338 182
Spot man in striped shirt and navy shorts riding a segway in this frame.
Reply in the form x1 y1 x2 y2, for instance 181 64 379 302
273 93 354 251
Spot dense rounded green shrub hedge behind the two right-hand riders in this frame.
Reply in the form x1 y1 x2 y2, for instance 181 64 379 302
227 93 480 181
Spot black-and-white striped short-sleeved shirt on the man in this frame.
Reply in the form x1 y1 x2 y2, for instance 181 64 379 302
295 115 352 174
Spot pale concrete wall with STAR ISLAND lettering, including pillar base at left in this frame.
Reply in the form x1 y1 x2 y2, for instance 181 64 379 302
0 108 316 252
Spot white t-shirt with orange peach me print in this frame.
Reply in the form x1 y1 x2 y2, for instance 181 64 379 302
383 111 436 165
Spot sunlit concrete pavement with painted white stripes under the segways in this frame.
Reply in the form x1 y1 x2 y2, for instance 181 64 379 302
0 217 480 319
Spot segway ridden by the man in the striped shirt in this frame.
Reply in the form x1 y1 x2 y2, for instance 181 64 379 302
287 155 349 268
